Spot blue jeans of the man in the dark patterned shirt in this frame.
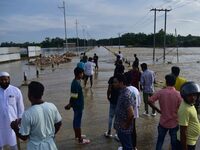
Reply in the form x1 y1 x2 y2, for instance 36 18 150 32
117 131 133 150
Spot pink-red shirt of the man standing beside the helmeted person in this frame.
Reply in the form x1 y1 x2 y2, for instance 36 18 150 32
149 86 182 128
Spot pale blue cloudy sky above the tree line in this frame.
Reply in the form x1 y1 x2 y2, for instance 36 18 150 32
0 0 200 43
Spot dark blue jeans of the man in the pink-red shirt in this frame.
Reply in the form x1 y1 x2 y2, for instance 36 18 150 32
156 124 178 150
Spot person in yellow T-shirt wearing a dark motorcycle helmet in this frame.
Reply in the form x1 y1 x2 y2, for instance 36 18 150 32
177 82 200 150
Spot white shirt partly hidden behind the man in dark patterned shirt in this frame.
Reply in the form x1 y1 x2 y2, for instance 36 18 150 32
127 86 141 118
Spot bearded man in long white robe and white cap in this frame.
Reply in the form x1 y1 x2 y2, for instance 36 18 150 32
0 72 24 150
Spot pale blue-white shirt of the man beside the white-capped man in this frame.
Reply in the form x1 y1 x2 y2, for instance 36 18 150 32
19 102 62 150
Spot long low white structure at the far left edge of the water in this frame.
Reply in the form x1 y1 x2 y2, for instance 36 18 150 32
0 47 21 62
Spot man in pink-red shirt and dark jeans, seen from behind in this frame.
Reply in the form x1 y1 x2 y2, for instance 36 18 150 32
148 74 182 150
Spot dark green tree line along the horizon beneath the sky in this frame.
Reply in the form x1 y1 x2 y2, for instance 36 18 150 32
0 29 200 48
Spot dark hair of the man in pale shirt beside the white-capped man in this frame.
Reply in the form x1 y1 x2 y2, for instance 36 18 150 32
28 81 44 99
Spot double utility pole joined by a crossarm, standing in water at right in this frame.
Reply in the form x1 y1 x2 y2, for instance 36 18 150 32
150 8 171 62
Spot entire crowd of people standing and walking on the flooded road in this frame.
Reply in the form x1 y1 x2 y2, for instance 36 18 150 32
0 51 200 150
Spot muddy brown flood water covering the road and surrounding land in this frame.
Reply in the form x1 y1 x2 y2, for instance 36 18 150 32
0 47 200 150
